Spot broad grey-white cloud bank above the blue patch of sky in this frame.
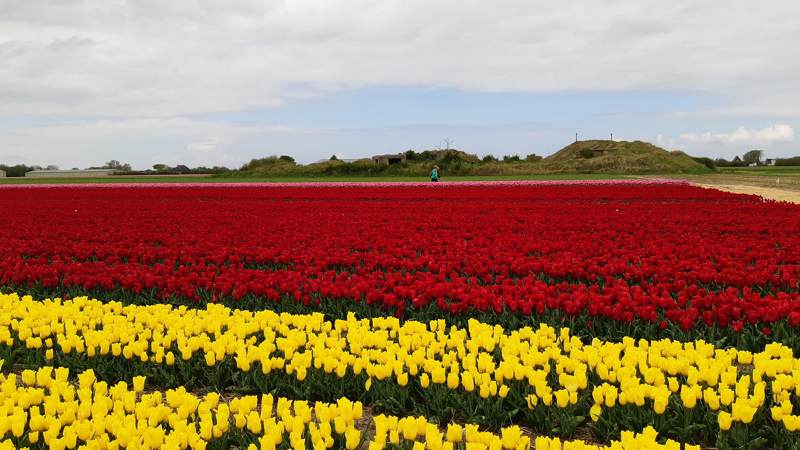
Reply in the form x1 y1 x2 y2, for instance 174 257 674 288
0 0 800 117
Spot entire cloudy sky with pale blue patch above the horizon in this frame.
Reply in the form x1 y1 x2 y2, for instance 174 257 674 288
0 0 800 169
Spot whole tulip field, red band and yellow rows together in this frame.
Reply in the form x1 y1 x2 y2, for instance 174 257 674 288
0 181 800 449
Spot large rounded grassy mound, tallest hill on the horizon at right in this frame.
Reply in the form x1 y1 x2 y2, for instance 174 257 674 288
541 140 708 173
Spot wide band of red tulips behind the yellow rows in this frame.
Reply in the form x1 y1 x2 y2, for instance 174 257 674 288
0 183 800 344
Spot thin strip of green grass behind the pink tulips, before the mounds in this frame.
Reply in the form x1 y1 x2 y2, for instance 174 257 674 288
0 173 628 184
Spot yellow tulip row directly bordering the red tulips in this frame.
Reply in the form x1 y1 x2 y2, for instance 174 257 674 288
0 294 800 446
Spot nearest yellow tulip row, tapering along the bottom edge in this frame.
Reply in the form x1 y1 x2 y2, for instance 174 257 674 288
0 362 699 450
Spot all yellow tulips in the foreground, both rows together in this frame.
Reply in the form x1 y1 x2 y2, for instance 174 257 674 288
0 294 800 448
